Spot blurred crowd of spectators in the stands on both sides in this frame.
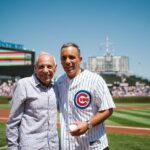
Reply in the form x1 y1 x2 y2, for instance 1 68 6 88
0 80 150 97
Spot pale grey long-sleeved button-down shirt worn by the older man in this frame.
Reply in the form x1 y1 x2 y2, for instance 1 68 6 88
7 75 59 150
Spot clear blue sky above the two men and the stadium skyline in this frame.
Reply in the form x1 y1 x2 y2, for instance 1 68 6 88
0 0 150 79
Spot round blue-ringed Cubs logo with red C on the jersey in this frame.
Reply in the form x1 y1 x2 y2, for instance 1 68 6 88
74 90 91 109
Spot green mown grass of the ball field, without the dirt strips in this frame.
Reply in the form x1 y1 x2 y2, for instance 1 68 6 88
0 103 150 150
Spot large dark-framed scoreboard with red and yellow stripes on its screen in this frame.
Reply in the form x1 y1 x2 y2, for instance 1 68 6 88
0 46 35 77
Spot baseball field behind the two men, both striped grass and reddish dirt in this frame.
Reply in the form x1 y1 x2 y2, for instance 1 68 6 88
0 99 150 150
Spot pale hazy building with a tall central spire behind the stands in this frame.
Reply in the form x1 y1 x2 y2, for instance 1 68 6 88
87 37 129 75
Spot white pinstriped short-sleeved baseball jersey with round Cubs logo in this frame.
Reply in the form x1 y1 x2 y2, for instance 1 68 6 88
57 70 115 150
